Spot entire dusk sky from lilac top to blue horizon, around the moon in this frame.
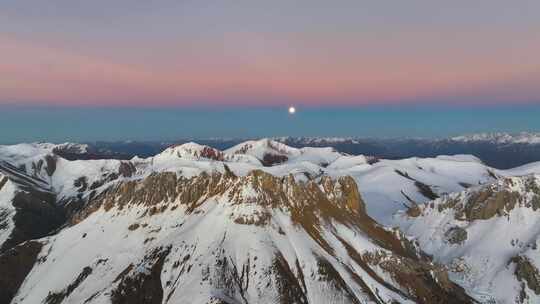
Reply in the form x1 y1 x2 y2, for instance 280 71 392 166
0 0 540 142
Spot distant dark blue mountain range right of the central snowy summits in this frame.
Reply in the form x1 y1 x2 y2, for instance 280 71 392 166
277 133 540 169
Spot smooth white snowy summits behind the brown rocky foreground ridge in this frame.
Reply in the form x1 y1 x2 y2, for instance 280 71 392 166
4 139 540 225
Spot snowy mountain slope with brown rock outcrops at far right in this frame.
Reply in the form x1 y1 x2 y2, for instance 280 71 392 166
396 175 540 303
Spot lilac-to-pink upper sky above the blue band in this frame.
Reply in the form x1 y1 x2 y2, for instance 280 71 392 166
0 0 540 107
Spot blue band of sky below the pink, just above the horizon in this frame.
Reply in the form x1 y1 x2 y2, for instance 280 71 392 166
0 104 540 144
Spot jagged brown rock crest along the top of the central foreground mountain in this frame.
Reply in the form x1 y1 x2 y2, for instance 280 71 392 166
75 168 365 223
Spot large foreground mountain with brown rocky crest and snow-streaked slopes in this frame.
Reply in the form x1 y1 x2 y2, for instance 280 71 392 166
0 170 470 303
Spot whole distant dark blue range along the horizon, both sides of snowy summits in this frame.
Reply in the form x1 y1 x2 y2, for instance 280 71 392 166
24 133 540 169
